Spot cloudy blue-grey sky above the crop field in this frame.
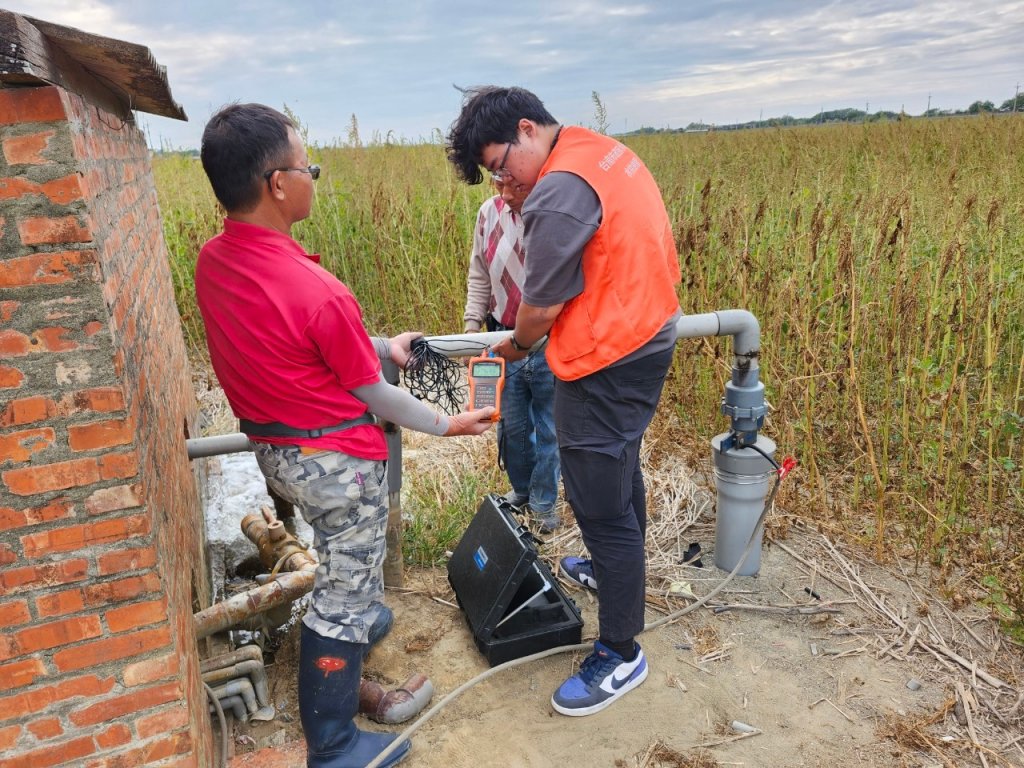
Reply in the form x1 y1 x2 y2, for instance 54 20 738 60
8 0 1024 148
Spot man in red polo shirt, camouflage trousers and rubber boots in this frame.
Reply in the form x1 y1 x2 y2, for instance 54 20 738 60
196 104 494 768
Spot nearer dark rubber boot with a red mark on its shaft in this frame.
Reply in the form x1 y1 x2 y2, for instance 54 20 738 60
299 625 411 768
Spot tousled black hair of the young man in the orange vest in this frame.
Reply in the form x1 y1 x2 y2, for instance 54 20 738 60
444 85 558 184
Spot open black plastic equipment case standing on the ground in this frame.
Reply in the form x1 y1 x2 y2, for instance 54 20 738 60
447 494 583 667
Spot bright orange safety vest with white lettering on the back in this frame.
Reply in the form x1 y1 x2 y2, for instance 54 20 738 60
527 127 679 381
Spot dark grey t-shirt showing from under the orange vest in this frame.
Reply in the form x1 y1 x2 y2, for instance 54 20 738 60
522 171 680 365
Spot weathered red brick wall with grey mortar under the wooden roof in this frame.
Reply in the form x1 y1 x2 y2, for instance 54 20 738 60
0 87 212 768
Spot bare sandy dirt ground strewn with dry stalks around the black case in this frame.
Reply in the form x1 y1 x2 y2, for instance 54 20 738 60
230 514 1024 768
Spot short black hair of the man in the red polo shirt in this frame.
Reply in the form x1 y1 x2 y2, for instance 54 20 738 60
200 103 295 212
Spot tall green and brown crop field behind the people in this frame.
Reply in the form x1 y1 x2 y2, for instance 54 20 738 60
155 115 1024 628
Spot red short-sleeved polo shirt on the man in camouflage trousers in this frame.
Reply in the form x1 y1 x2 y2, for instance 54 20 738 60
196 219 387 460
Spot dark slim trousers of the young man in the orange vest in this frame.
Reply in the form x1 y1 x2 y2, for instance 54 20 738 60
555 347 675 642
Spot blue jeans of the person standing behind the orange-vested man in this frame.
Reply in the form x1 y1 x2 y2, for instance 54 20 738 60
498 352 560 515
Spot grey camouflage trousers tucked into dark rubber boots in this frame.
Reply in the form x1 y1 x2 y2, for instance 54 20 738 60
252 442 387 643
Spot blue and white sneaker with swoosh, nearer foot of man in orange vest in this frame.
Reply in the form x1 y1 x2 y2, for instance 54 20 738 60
551 641 647 717
